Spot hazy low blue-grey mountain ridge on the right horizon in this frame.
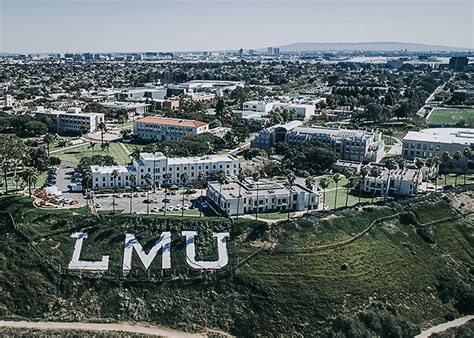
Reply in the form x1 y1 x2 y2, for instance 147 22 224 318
272 42 469 52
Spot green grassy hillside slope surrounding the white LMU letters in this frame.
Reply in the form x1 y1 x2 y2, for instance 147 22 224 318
0 196 474 336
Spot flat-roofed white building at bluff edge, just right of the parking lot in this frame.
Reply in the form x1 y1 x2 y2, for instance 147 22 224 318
206 180 319 216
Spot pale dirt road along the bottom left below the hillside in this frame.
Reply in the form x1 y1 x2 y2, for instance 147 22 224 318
0 321 206 337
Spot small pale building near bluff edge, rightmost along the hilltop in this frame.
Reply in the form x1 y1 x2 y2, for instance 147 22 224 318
361 168 423 196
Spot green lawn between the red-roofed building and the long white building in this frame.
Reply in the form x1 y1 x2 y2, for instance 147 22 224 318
53 143 130 165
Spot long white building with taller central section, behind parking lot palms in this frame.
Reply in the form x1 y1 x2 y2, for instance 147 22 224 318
91 152 240 189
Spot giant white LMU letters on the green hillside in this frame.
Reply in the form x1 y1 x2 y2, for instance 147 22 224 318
69 231 230 274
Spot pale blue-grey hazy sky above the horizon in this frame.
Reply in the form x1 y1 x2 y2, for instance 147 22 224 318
0 0 474 53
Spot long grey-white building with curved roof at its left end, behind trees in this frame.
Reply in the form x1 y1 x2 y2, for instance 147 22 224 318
252 121 384 162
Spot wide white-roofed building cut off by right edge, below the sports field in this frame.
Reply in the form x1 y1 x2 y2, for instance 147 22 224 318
402 128 474 165
